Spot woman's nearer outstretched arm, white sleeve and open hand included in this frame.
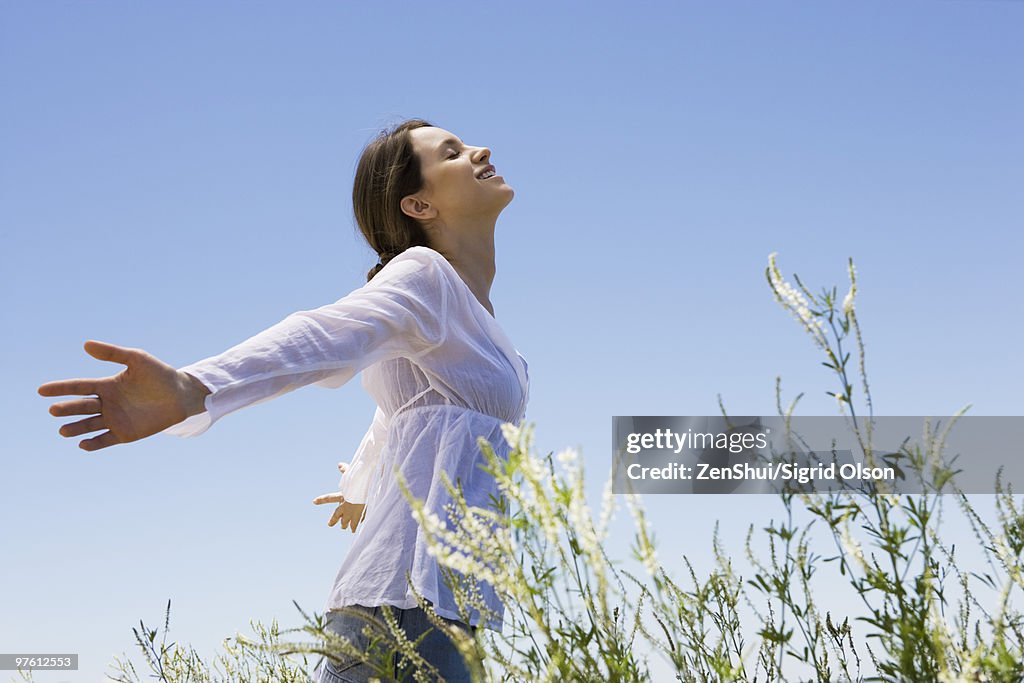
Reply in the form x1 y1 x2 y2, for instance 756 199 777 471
39 247 452 451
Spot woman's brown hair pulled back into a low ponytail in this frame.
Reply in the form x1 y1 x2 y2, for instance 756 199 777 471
352 119 433 283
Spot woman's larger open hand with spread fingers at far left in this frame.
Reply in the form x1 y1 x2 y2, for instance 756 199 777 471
38 340 210 451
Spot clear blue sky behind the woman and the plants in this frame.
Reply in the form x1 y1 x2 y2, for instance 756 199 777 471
0 0 1024 681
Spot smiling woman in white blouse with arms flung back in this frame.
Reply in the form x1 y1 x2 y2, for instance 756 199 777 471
39 119 529 681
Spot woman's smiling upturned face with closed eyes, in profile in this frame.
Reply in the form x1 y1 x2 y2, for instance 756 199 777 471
402 126 515 232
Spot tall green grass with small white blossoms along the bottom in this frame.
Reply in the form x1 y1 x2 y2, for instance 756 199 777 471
12 254 1024 683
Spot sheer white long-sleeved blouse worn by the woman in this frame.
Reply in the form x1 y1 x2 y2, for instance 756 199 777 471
164 247 529 631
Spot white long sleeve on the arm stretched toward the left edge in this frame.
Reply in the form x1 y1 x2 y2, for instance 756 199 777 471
164 247 451 436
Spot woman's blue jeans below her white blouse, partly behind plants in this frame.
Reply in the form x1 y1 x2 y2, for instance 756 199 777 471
314 605 476 683
